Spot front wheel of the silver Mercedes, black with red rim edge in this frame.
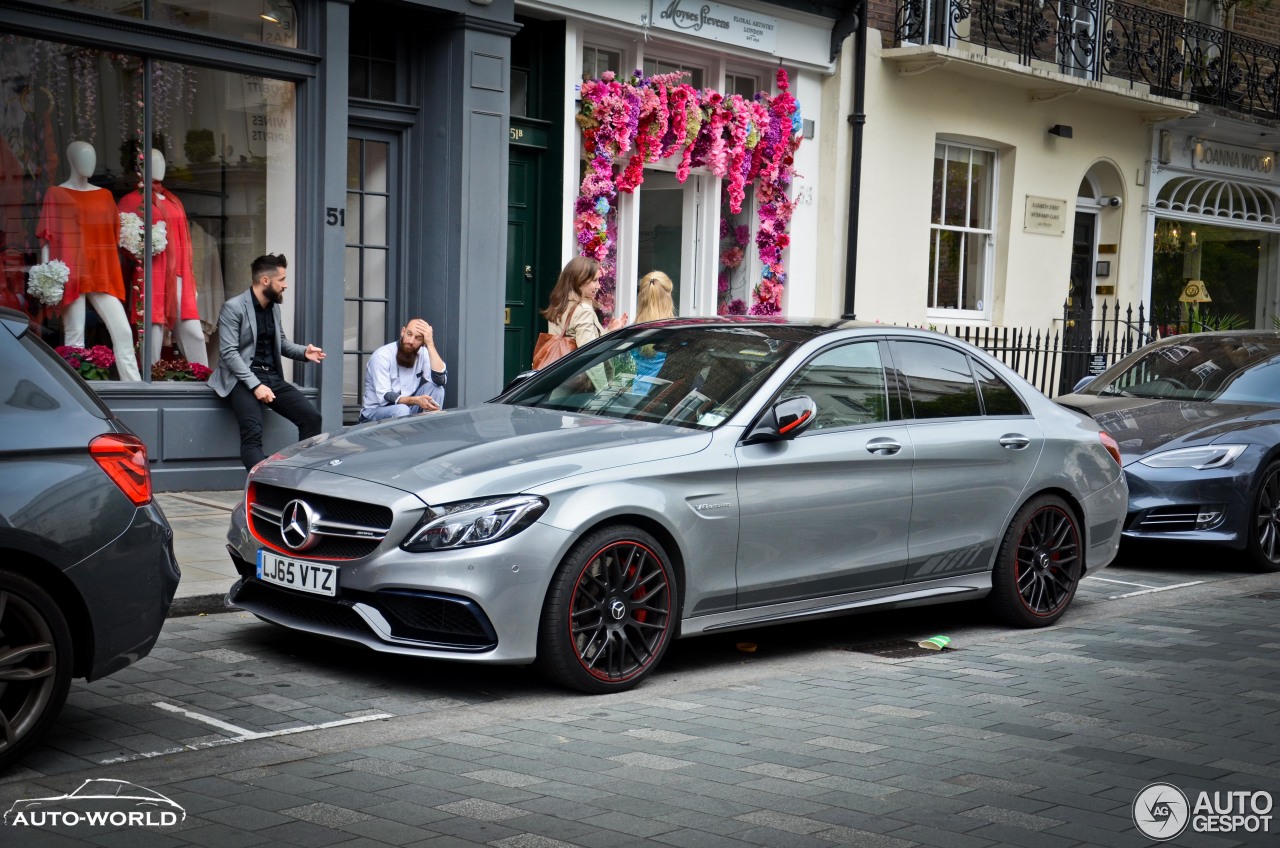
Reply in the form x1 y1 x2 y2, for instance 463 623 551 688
538 525 678 694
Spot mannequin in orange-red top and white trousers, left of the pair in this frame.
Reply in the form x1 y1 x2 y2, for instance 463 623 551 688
36 141 142 380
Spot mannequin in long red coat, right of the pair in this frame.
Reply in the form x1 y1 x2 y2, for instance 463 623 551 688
120 147 209 365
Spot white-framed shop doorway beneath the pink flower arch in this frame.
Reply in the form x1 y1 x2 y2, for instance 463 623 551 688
637 169 704 315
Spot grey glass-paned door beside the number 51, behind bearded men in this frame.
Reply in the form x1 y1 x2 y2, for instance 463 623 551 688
340 126 403 424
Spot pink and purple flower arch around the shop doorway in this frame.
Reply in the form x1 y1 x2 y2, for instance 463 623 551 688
573 68 803 315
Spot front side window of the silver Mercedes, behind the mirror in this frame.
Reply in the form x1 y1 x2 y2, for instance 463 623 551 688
780 342 888 430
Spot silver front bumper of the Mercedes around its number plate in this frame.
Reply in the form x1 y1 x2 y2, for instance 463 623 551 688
227 505 572 664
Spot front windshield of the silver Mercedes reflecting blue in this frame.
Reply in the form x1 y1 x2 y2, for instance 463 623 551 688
502 325 812 430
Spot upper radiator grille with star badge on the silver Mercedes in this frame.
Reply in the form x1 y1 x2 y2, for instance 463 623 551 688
247 483 392 560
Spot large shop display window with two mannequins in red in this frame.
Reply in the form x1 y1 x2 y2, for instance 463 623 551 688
0 36 297 380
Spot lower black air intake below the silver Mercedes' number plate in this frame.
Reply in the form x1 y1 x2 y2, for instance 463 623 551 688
232 578 498 651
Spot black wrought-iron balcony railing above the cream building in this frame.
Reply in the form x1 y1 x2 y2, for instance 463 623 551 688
895 0 1280 119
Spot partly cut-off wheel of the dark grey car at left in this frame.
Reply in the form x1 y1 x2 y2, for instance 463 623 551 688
0 570 74 771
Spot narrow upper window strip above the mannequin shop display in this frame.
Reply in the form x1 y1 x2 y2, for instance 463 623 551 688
52 0 298 47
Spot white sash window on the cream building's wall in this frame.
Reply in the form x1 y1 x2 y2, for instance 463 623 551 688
928 142 996 318
